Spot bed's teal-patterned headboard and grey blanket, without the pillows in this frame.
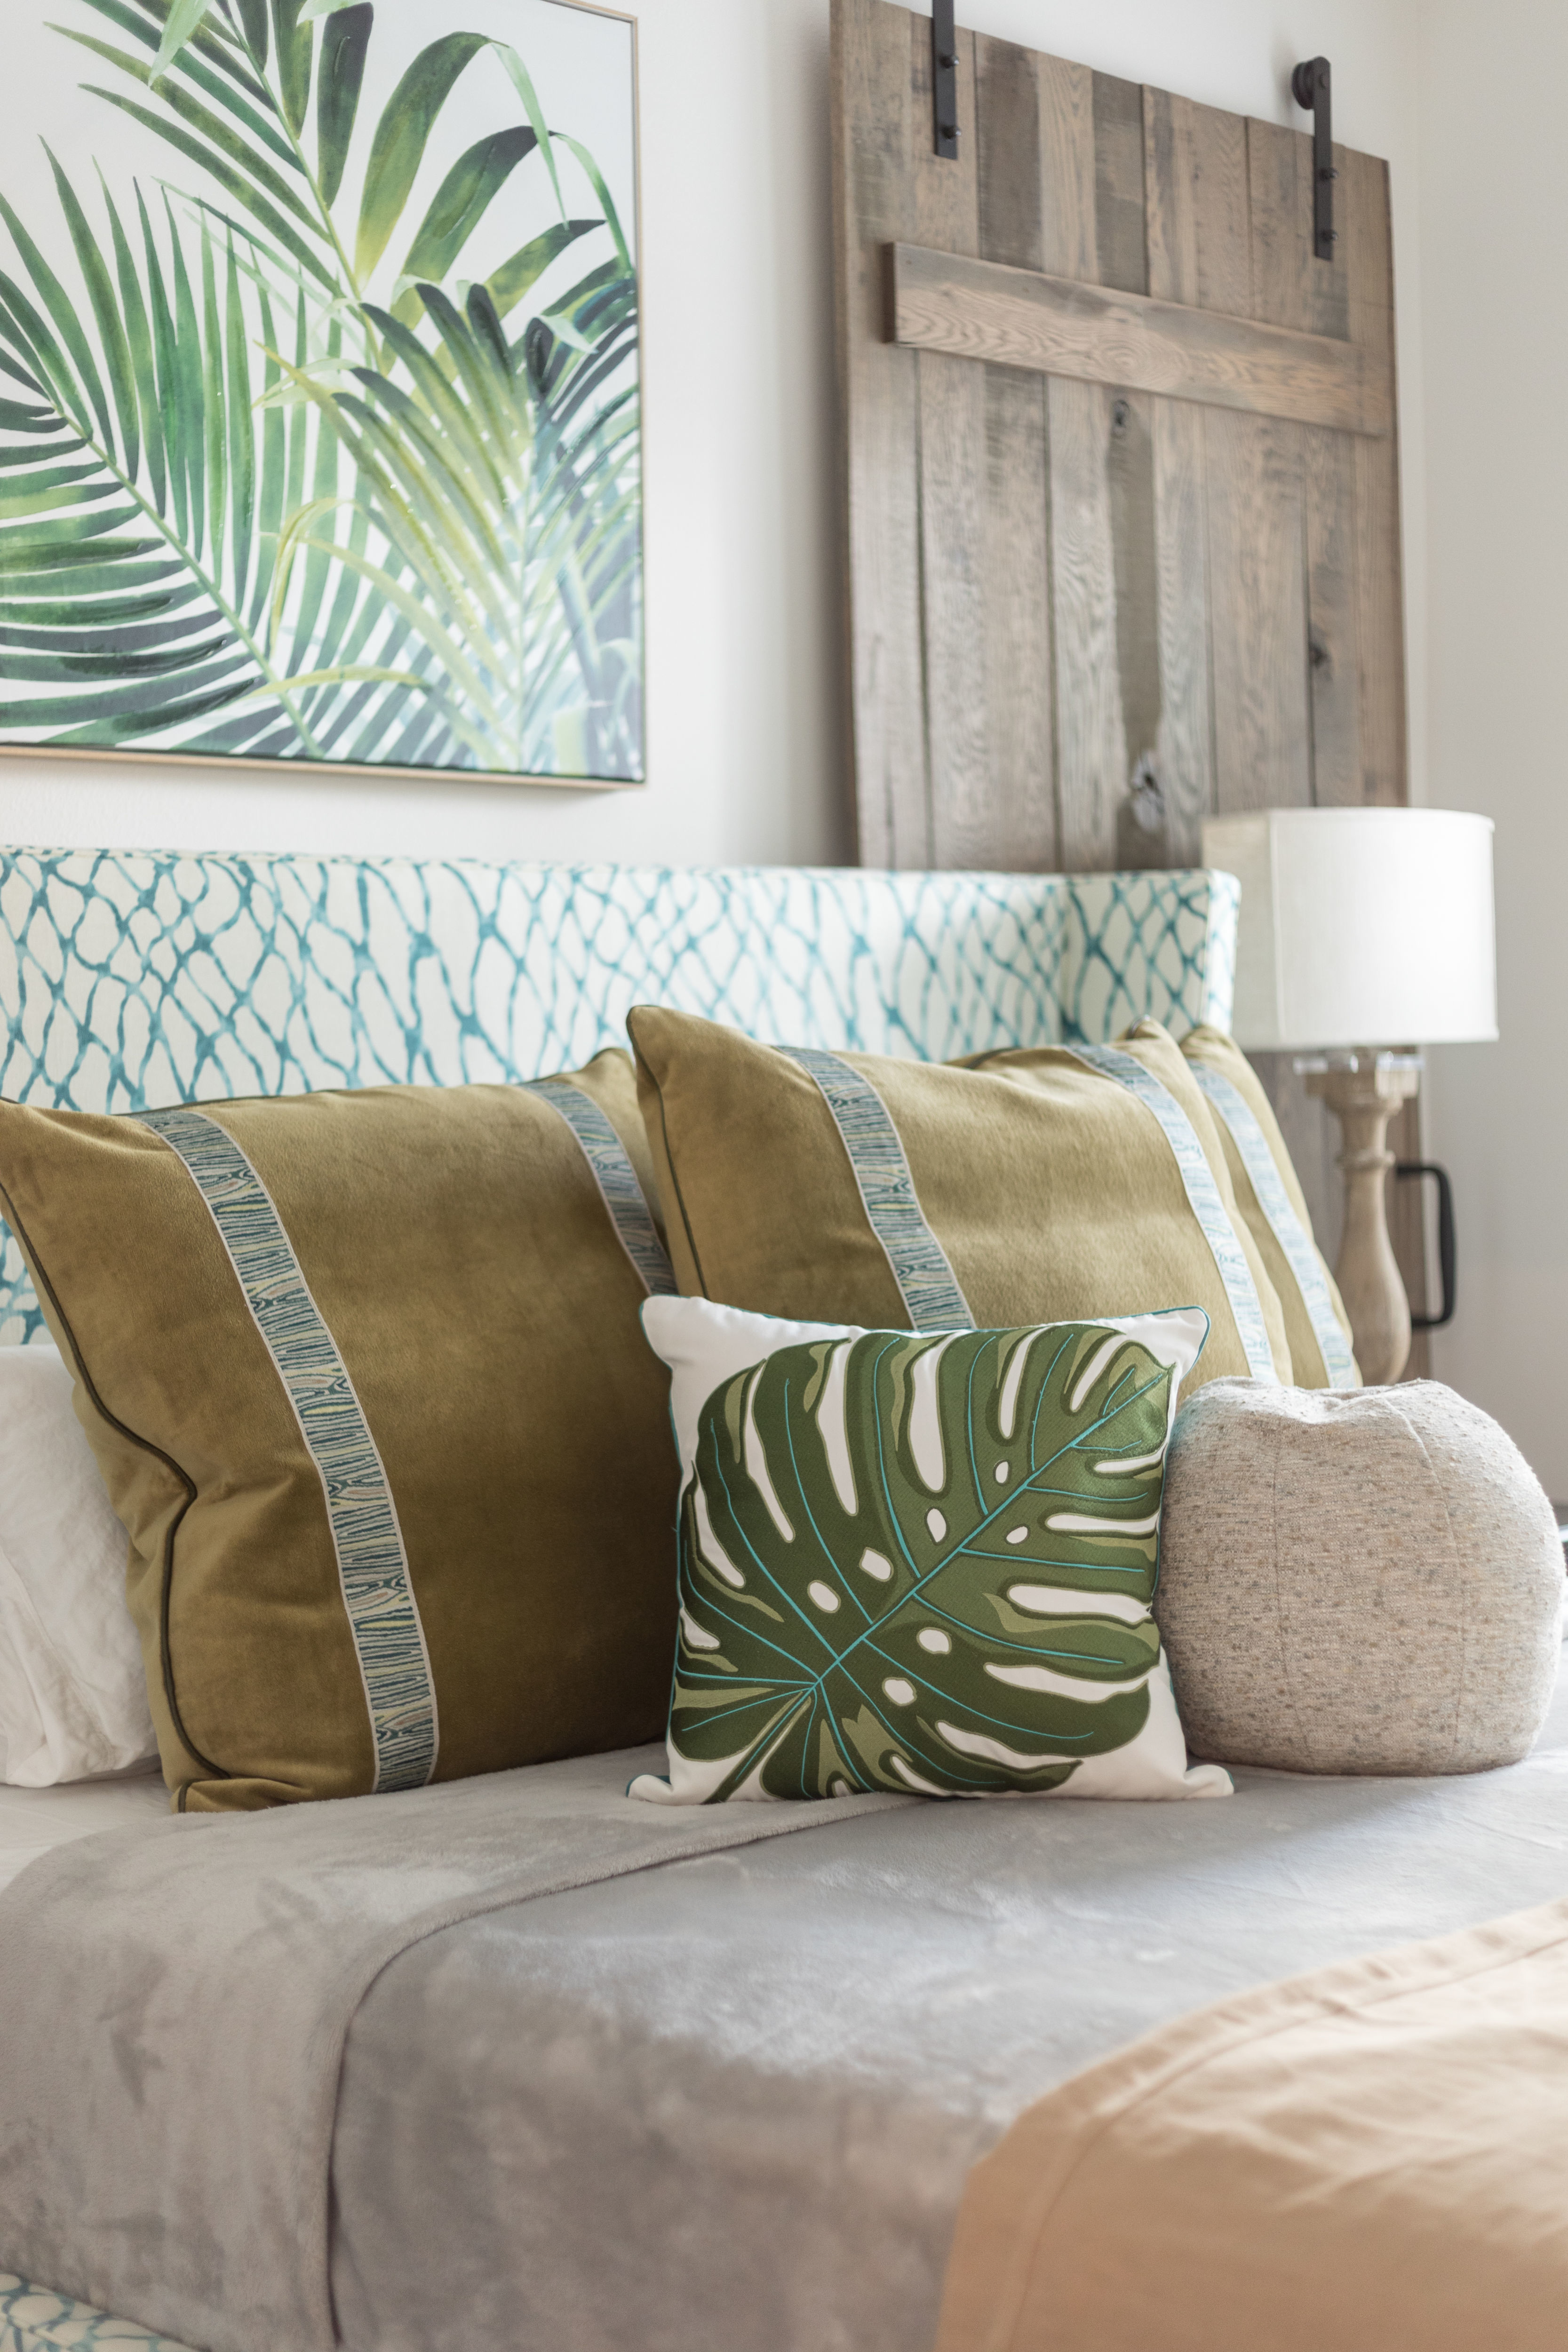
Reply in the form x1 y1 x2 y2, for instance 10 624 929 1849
0 851 1568 2352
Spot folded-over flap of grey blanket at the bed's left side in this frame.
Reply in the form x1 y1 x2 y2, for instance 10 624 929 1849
0 1748 917 2352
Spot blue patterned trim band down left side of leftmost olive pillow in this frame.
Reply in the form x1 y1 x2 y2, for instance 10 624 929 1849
139 1110 439 1790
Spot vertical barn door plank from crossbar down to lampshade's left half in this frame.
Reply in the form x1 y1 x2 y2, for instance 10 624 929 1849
1203 409 1312 811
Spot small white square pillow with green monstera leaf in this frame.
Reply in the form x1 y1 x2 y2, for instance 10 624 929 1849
632 1298 1229 1804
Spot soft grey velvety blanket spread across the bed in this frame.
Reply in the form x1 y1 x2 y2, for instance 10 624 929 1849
0 1656 1568 2352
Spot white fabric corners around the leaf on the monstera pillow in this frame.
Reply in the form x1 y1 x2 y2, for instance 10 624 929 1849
628 1298 1232 1804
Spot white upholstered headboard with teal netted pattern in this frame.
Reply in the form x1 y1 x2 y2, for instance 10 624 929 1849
0 849 1236 1343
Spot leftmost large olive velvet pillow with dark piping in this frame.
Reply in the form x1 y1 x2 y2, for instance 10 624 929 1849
0 1051 675 1811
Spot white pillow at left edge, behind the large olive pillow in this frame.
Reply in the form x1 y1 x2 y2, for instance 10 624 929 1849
0 1345 158 1788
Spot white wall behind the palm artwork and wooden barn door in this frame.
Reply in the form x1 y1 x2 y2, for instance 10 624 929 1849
0 0 1422 863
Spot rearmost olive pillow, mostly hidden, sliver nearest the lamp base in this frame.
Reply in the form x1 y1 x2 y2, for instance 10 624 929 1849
1182 1028 1361 1388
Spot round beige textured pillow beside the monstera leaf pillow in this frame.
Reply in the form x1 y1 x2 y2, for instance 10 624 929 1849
1154 1381 1563 1773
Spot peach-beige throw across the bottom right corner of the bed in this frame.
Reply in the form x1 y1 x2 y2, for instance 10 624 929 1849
938 1900 1568 2352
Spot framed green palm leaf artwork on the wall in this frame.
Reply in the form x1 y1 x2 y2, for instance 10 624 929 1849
0 0 644 783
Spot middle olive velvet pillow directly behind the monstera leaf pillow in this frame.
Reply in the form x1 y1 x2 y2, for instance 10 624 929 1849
630 1007 1290 1383
